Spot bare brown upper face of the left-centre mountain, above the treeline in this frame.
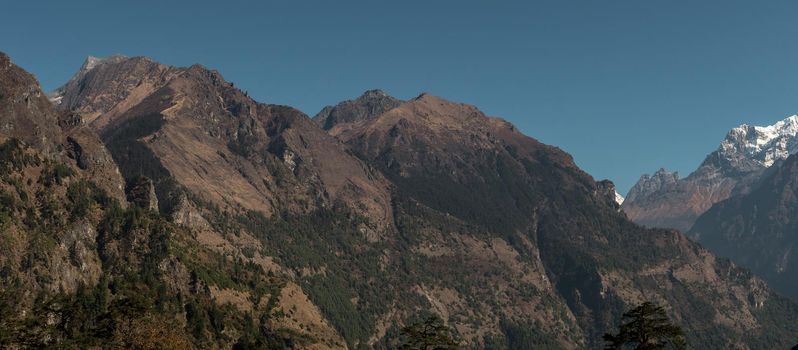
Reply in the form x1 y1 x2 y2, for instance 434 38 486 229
54 58 390 232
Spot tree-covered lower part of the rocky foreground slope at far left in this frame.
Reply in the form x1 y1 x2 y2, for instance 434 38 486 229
0 146 304 349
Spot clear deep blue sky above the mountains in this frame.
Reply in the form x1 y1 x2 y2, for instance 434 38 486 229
0 0 798 193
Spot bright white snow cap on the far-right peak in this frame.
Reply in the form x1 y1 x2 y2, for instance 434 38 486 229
719 115 798 167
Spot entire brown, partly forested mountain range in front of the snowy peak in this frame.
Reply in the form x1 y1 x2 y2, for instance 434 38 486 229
0 54 798 349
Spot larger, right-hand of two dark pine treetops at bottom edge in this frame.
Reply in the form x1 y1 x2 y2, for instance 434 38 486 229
604 302 687 350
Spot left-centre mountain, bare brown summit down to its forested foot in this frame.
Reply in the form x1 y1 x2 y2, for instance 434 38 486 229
56 56 583 348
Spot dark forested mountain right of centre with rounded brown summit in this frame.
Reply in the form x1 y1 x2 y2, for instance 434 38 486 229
322 94 796 348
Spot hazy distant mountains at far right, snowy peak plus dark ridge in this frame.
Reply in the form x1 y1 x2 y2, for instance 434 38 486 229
623 116 798 304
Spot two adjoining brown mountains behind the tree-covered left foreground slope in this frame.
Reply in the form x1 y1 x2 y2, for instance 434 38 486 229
32 54 798 349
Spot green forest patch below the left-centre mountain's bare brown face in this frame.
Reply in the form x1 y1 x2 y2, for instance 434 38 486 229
231 210 394 346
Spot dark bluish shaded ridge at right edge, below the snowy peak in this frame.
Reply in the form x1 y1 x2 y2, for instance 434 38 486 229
690 155 798 298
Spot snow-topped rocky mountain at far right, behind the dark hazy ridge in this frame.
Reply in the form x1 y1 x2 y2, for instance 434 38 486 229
623 116 798 231
